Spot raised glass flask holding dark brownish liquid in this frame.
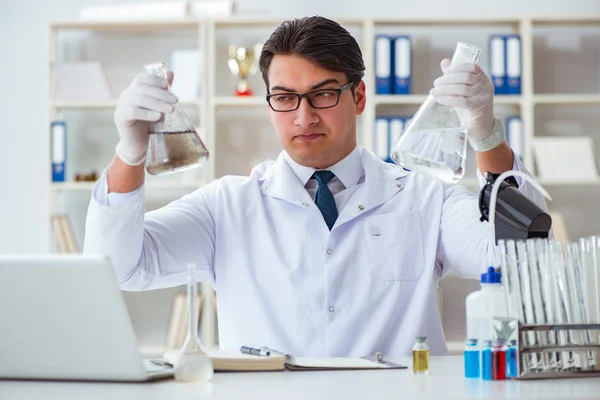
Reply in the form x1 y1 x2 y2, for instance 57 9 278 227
144 62 208 175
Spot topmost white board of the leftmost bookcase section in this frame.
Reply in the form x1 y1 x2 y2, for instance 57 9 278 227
50 18 200 32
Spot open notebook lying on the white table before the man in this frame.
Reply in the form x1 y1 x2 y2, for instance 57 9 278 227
163 350 406 372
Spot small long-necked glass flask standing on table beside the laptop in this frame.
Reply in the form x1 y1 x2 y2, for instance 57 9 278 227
174 264 214 382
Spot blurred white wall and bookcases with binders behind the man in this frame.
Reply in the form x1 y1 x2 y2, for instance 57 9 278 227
0 0 600 390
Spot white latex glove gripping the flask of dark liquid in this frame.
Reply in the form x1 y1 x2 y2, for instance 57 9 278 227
114 72 177 165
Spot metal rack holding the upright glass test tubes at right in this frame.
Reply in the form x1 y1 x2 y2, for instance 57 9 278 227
513 322 600 380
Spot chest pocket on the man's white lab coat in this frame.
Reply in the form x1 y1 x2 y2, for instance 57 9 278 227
365 211 425 281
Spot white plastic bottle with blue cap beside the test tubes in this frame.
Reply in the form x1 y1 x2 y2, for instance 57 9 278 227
466 267 508 343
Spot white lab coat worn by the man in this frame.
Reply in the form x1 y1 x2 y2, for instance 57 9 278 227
85 149 545 356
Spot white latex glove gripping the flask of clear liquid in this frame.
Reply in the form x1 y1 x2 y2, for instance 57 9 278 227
430 59 494 141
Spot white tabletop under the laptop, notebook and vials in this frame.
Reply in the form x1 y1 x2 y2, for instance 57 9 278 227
0 356 600 400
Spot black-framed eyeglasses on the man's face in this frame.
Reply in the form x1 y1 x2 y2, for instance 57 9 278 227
267 82 354 112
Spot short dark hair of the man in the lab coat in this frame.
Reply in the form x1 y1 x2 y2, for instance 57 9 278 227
258 16 365 92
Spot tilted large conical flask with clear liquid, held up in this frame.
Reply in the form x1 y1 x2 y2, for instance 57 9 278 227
390 42 481 183
